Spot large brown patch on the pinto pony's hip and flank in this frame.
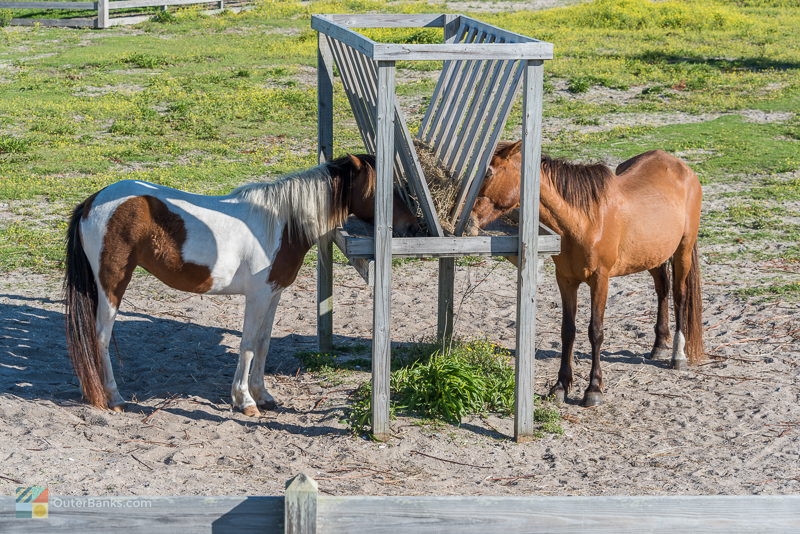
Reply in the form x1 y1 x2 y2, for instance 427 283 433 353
100 195 213 307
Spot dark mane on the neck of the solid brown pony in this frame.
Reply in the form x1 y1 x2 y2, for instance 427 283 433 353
542 155 614 214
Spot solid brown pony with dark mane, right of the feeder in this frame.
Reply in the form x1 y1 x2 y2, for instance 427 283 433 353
472 141 703 406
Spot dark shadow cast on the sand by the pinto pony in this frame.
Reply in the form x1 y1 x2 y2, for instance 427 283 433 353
0 294 364 435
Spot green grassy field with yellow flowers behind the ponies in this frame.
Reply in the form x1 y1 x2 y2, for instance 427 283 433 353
0 0 800 297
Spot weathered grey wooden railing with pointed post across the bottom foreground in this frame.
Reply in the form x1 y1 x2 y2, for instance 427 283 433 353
0 475 800 534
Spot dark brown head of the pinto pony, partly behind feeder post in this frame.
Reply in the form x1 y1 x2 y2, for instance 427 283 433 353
348 154 422 237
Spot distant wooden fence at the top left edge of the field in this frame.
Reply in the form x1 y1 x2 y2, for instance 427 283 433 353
0 0 244 29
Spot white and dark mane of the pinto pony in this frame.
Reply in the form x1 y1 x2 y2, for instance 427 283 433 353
231 154 375 243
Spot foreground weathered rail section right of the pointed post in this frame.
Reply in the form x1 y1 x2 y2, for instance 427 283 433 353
318 495 800 534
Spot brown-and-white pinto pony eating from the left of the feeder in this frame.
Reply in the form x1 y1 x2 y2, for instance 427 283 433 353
64 155 419 416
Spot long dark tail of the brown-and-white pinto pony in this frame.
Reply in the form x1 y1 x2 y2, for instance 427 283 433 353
64 197 108 408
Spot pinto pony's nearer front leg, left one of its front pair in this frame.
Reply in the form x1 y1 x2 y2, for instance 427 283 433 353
231 288 271 416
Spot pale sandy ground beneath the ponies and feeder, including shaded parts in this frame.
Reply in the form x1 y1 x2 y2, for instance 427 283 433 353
0 255 800 495
